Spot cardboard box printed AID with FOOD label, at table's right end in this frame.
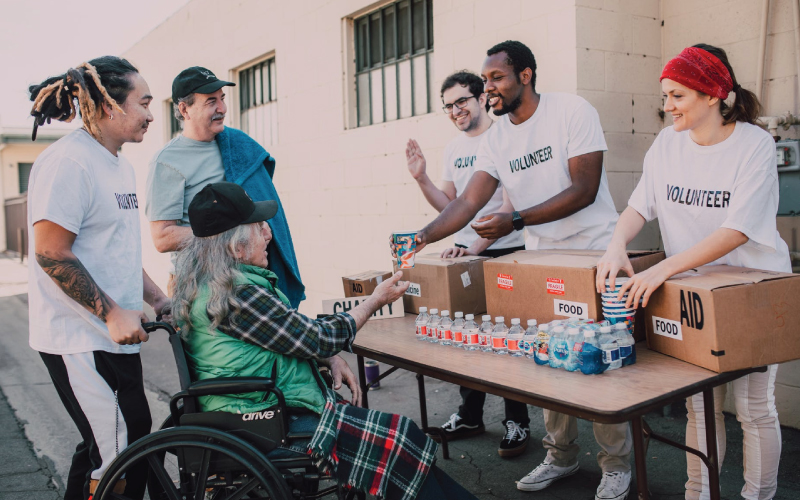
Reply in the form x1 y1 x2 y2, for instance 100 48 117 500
645 266 800 372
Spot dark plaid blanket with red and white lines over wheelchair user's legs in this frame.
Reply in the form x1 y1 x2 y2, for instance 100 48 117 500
309 390 438 500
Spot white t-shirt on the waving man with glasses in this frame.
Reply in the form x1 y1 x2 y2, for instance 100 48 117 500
442 132 525 250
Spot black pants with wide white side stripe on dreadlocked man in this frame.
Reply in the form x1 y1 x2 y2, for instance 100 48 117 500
40 351 152 500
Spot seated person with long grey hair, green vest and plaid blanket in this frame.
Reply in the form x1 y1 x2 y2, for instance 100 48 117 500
173 182 475 499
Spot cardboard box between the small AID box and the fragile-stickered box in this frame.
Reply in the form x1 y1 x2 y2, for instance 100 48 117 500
394 254 487 318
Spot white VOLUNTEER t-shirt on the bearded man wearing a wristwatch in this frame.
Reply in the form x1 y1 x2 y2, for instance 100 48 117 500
475 92 619 250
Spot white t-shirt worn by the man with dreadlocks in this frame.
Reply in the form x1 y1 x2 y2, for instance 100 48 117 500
28 129 143 354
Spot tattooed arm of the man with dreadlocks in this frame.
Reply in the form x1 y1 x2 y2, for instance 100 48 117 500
33 220 149 344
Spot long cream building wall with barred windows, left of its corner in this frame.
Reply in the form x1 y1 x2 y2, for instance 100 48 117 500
124 0 577 313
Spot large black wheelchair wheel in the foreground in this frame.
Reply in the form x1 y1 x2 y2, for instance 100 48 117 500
94 426 292 500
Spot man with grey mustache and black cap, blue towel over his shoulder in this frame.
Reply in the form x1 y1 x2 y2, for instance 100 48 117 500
145 66 305 307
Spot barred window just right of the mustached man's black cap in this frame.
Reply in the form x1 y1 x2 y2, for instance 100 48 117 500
239 57 278 146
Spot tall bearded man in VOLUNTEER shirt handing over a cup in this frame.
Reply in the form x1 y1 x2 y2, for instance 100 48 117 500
417 41 632 500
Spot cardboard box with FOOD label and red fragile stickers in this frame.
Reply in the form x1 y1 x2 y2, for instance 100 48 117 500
483 250 664 340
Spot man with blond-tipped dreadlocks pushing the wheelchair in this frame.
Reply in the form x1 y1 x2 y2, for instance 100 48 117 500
28 56 169 500
